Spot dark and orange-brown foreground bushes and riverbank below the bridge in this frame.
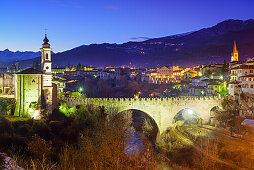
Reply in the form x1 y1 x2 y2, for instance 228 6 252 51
0 98 254 170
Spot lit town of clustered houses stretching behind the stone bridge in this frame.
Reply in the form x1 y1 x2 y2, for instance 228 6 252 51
0 42 254 98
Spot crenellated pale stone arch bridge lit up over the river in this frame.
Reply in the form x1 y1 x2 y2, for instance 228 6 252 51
62 97 223 134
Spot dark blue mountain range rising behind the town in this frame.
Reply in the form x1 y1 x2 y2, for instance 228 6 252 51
0 19 254 67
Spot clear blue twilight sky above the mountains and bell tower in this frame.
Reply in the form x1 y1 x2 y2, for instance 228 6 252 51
0 0 254 52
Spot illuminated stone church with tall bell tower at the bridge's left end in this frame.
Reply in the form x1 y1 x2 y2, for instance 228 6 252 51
14 34 59 119
